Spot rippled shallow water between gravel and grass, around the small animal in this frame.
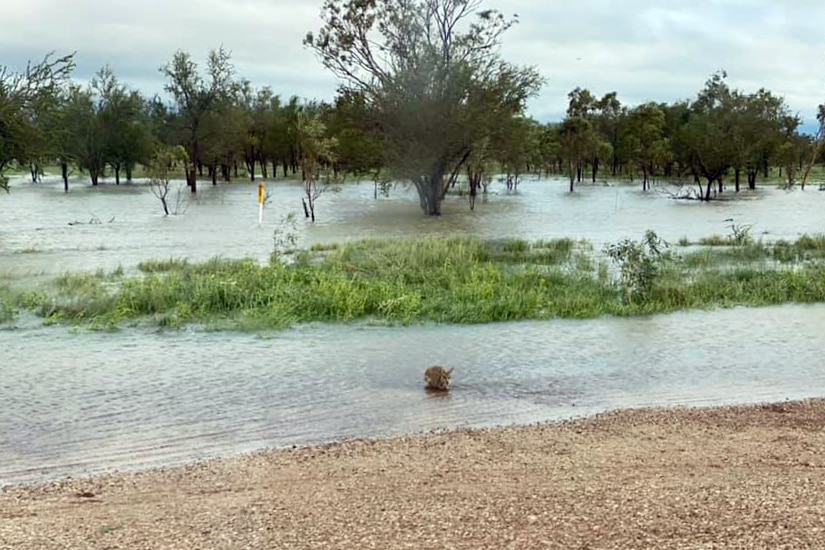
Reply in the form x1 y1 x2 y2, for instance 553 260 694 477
0 305 825 485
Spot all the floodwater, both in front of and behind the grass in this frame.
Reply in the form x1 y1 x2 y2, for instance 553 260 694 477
0 179 825 486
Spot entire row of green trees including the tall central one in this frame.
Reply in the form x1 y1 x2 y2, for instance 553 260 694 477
0 0 825 215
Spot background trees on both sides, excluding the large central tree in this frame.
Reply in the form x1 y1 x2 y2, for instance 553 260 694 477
0 49 825 203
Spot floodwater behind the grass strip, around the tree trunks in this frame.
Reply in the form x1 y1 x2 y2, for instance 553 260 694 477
0 178 825 277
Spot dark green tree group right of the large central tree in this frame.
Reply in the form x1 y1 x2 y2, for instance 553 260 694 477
552 71 825 200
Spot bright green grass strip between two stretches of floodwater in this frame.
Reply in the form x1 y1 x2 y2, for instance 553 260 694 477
9 237 825 330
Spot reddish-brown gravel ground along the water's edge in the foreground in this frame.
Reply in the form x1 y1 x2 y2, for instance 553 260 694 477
0 400 825 550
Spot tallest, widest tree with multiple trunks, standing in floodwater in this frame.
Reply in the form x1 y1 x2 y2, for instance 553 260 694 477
304 0 542 215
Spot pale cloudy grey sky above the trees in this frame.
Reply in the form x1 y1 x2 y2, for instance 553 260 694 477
0 0 825 131
